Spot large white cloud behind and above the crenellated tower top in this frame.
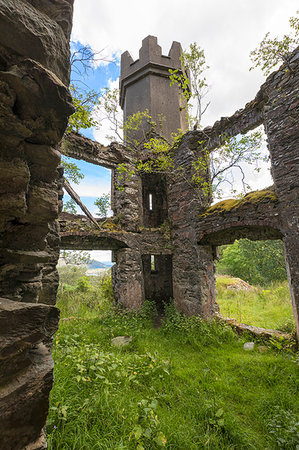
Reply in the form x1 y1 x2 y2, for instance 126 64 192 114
73 0 298 125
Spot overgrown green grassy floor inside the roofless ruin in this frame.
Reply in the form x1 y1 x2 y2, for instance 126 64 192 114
47 284 299 450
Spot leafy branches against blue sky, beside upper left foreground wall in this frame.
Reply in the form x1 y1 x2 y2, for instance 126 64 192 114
67 84 99 133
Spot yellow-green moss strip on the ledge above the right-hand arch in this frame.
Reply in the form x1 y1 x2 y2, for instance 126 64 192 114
200 189 278 217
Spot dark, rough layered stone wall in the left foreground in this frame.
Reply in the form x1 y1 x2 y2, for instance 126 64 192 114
0 0 73 450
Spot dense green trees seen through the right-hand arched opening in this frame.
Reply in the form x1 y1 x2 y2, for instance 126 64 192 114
218 239 287 285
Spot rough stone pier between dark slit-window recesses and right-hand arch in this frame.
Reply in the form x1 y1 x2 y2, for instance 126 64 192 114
168 132 218 318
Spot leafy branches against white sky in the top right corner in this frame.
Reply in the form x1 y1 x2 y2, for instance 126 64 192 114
249 12 299 75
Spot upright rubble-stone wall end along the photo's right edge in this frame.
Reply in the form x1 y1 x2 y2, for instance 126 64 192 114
265 52 299 340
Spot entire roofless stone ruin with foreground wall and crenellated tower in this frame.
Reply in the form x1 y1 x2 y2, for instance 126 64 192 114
0 0 299 450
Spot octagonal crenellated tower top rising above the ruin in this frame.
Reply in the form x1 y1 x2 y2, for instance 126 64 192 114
120 36 188 141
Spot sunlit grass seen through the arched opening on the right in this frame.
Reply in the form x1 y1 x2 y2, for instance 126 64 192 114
216 275 295 332
